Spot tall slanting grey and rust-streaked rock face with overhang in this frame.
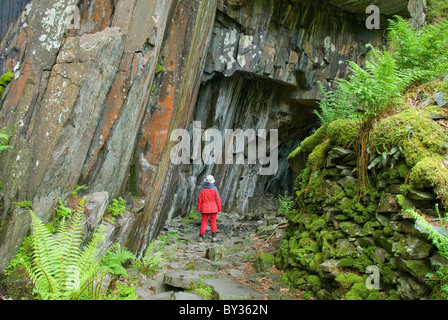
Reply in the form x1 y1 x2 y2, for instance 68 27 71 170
0 0 424 270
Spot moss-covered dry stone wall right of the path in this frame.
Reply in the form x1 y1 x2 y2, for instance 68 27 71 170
275 114 443 300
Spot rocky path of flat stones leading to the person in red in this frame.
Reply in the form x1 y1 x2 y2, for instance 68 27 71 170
128 199 291 300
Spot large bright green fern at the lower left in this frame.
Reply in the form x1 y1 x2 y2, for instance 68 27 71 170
19 198 132 300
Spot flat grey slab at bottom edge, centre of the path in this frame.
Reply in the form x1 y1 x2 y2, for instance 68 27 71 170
204 278 262 300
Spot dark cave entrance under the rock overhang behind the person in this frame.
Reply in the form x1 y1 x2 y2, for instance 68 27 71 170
185 72 319 212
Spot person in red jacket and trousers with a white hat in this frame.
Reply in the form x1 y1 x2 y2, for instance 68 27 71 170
197 175 221 242
